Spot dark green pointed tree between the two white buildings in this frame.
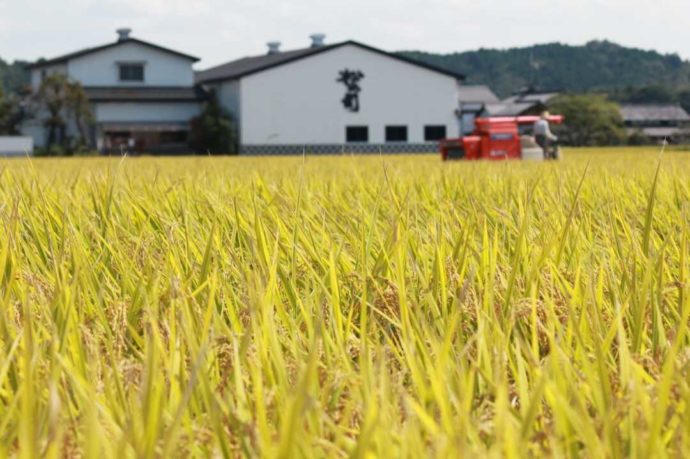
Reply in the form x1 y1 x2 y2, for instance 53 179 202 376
191 92 237 155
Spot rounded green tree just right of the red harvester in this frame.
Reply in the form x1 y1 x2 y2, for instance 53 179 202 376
549 94 626 146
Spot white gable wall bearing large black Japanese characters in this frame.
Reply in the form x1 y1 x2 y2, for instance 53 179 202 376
240 45 458 145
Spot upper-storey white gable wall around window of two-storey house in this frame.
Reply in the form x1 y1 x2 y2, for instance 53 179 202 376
68 43 194 86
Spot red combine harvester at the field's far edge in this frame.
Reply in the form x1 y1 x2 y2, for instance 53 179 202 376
440 115 563 161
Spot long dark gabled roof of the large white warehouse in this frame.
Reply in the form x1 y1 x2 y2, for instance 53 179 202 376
196 40 465 83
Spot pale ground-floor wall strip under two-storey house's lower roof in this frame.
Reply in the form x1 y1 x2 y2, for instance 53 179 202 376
93 102 199 123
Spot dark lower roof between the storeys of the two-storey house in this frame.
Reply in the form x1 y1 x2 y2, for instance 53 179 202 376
84 87 206 102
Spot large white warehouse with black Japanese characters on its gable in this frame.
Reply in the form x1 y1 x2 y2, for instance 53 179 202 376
196 34 464 154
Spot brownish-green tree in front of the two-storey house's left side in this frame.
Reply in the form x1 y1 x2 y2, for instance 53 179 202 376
35 73 93 152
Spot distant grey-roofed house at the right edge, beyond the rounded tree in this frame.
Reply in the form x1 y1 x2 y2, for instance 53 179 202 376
620 104 690 142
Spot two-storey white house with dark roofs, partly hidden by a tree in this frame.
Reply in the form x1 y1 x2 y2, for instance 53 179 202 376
23 29 203 153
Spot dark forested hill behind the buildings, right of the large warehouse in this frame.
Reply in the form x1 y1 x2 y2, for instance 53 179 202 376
400 41 690 97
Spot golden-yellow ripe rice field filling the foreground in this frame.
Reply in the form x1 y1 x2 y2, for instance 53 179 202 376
0 149 690 458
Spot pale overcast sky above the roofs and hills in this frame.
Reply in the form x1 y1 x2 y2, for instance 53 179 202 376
0 0 690 68
